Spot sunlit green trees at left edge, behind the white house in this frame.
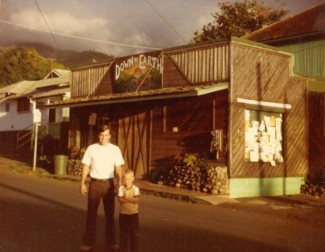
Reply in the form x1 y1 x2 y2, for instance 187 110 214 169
0 47 65 87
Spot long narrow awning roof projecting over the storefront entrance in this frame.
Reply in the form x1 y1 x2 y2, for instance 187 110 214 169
43 82 229 108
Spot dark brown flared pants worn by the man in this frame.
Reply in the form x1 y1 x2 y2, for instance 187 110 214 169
83 179 116 246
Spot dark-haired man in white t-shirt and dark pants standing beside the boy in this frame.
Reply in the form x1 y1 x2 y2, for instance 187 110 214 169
80 125 124 251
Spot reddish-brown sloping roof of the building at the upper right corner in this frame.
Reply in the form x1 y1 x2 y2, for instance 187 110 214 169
243 3 325 42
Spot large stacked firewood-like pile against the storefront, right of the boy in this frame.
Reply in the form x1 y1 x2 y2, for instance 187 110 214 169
158 154 228 194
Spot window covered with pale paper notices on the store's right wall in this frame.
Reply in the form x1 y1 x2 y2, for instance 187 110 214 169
245 110 283 166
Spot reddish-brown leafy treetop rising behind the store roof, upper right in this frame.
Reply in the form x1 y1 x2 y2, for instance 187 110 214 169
191 0 288 43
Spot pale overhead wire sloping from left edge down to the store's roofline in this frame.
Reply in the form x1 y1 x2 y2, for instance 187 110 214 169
0 19 162 50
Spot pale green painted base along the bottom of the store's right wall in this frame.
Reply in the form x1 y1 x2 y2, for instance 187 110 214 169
229 177 305 198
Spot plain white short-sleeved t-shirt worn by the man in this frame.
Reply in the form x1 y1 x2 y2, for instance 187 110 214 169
82 143 124 179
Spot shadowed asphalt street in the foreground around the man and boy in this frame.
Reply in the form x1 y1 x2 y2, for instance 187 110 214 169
0 170 325 252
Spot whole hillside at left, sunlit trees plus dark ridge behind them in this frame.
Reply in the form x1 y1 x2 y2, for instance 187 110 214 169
0 44 113 88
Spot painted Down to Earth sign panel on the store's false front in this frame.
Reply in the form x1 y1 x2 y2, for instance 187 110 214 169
113 51 162 93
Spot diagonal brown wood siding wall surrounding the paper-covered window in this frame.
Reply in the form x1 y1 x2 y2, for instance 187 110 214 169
229 43 308 177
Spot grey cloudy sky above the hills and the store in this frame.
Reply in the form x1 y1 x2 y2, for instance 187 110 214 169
0 0 325 56
